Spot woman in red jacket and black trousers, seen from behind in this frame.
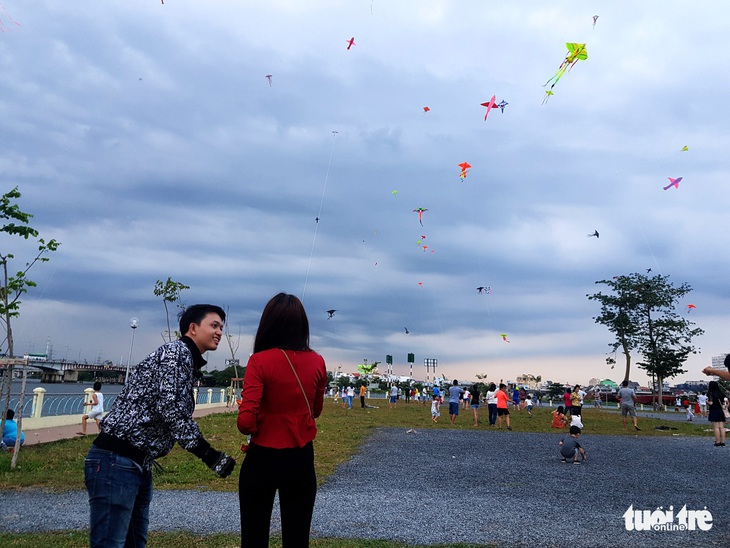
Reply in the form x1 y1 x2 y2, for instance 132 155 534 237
238 293 327 548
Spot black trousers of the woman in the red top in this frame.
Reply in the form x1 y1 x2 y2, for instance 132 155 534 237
238 442 317 548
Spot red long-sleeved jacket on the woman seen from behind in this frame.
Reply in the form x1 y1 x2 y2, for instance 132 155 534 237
237 348 327 449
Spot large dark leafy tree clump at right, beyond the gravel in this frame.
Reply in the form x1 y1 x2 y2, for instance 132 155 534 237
587 273 704 397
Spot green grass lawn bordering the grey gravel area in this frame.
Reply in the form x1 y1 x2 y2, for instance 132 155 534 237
0 400 712 548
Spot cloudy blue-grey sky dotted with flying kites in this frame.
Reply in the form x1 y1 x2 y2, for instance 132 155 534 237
0 0 730 385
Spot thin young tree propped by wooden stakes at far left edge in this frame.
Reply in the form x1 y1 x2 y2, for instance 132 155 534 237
0 187 61 467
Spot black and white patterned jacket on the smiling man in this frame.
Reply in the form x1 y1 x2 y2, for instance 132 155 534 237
100 337 209 459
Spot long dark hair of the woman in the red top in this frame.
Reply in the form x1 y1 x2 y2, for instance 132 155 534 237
253 293 311 353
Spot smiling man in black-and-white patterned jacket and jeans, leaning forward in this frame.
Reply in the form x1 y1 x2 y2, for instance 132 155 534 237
84 304 236 548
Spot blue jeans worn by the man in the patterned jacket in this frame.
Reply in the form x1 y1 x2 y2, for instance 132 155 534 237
84 445 152 548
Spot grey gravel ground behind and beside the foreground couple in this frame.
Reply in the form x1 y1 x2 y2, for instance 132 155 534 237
0 429 730 547
